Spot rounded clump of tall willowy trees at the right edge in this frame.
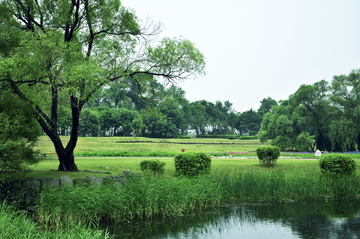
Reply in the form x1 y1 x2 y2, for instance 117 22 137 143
259 70 360 151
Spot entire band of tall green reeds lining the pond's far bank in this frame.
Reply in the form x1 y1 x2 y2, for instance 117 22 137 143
1 166 360 238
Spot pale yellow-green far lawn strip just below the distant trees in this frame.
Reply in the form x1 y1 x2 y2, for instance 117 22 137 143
35 136 261 154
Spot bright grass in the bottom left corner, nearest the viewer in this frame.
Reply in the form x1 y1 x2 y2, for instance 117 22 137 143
0 202 110 239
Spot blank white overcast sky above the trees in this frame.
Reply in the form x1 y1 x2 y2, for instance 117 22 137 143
122 0 360 112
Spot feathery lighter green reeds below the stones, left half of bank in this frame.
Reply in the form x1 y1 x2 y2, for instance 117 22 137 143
36 176 222 224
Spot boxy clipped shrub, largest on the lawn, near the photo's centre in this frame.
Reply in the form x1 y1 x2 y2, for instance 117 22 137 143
175 153 211 176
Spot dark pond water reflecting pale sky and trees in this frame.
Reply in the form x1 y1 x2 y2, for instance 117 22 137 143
103 200 360 239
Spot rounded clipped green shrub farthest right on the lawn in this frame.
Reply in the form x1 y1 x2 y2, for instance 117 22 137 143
319 154 356 177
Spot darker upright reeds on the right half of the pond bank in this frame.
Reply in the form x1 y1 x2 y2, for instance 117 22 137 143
213 168 360 202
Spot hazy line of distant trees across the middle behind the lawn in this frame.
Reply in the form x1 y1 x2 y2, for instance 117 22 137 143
58 76 277 138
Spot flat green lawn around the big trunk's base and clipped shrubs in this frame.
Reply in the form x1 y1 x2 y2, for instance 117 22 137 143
0 157 352 179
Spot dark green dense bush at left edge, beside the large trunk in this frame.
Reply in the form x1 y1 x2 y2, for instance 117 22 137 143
0 92 40 171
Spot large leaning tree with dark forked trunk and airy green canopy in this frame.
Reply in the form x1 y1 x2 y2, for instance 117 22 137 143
0 0 205 171
